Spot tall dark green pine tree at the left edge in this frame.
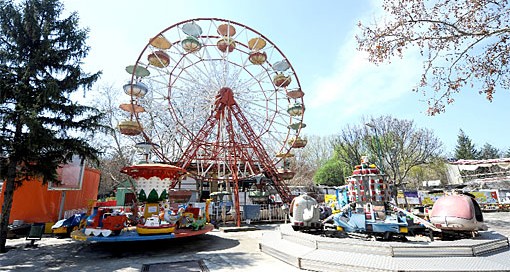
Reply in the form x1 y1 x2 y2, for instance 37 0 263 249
0 0 104 252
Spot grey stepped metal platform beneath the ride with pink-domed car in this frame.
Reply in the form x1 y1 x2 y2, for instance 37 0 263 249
259 224 510 272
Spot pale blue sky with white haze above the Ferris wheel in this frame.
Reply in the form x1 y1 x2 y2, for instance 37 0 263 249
62 0 510 154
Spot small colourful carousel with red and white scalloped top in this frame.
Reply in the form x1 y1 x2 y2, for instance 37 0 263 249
71 155 214 243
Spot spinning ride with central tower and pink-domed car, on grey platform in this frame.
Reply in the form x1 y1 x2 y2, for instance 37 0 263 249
289 157 487 240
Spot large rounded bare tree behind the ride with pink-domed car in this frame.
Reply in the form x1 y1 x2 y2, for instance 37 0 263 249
335 116 442 203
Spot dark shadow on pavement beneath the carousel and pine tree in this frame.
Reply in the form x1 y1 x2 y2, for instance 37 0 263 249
0 234 239 272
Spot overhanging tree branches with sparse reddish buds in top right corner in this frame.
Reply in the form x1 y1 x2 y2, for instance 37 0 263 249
356 0 510 115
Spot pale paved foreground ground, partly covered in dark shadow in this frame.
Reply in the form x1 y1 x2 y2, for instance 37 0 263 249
0 212 510 272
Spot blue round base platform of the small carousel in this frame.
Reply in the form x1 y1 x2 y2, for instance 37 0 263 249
71 224 214 243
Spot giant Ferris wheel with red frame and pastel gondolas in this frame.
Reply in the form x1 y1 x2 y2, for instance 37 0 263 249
119 18 306 203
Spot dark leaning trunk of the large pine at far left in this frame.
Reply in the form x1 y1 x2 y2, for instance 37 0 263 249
0 161 17 253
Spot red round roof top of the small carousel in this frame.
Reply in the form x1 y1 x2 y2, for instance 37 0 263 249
120 163 186 179
